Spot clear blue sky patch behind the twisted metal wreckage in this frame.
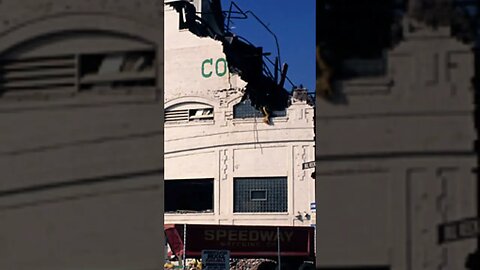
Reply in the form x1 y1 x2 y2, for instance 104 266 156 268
222 0 315 92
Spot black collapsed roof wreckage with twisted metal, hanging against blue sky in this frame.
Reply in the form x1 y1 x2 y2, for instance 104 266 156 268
165 0 290 114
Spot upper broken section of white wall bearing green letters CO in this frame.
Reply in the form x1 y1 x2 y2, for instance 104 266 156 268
164 5 245 102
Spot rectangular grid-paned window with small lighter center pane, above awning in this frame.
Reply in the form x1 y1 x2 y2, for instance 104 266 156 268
233 177 288 213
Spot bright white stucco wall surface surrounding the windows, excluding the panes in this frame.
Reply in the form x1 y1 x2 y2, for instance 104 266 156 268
165 2 315 226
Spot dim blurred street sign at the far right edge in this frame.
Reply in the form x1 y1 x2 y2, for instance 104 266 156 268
438 217 480 244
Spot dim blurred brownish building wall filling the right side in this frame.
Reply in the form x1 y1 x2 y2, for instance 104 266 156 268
316 6 478 270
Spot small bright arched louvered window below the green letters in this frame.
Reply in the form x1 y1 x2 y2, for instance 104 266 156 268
165 102 213 123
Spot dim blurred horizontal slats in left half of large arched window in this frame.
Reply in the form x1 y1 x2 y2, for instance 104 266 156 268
0 55 76 93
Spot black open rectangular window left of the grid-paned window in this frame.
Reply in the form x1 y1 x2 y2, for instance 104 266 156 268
164 179 213 213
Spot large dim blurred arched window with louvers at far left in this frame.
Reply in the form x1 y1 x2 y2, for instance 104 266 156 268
0 31 156 97
